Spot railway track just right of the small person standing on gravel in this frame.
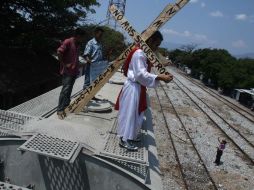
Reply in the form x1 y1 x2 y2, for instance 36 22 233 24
171 77 254 164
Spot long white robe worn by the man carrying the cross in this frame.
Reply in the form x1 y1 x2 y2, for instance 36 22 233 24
118 49 158 141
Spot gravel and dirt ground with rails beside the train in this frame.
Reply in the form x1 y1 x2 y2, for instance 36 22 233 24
148 70 254 190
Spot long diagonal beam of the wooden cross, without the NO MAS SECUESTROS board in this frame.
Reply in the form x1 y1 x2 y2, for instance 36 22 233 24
62 0 190 117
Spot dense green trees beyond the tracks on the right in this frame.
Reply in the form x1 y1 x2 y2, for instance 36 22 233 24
169 46 254 93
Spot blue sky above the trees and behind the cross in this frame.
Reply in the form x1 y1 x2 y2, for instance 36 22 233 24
86 0 254 55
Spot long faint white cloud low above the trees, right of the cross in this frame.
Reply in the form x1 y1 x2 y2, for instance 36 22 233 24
162 29 216 45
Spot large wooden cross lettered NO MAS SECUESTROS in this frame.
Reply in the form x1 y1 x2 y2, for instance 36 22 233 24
62 0 190 117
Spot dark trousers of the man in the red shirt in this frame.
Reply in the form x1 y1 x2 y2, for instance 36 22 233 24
57 74 76 112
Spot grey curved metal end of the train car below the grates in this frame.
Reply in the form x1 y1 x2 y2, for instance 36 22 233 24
0 140 148 190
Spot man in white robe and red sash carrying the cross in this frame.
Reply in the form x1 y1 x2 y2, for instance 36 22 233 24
116 31 173 150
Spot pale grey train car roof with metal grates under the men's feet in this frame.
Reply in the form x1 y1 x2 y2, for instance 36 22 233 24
1 72 162 190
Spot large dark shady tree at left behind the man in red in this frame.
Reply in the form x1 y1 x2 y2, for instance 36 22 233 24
0 0 98 109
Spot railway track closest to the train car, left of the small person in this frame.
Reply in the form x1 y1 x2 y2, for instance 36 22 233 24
152 86 218 190
